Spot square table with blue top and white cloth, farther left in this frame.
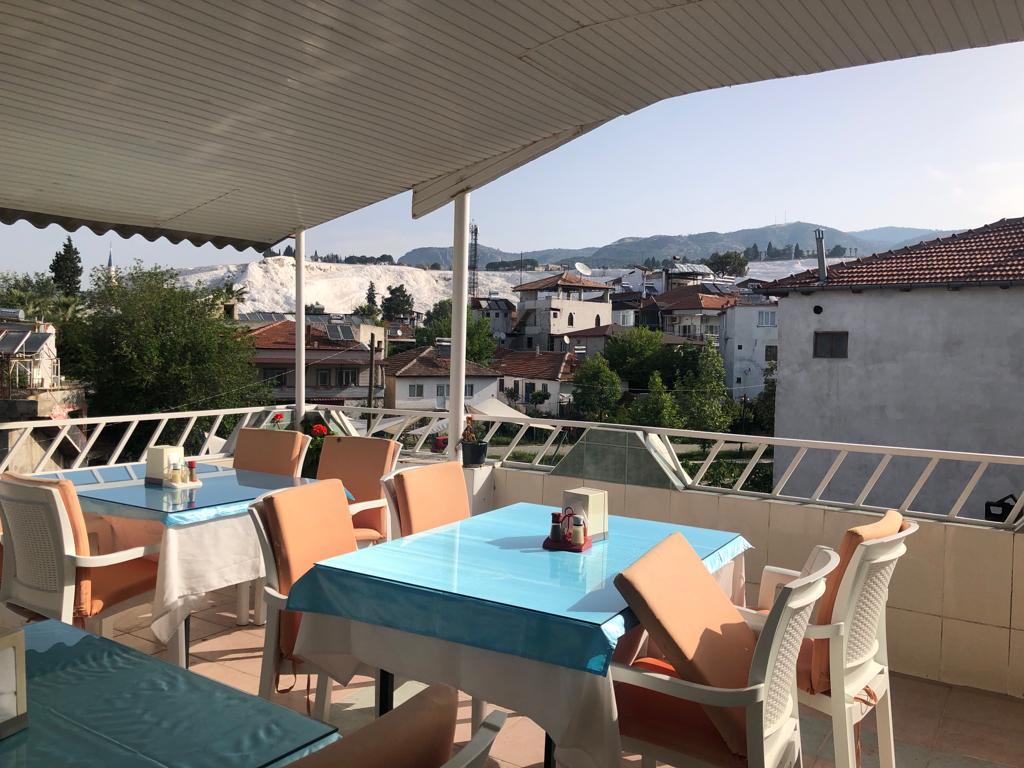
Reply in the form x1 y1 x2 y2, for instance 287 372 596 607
44 463 312 667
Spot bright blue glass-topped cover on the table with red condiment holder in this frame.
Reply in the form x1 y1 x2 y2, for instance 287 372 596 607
288 504 750 674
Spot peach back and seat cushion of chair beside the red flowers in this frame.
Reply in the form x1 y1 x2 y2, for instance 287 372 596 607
316 435 401 542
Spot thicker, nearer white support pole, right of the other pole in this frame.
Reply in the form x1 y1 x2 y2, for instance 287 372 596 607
449 191 469 459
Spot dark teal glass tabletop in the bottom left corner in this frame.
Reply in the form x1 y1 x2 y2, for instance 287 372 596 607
0 622 337 768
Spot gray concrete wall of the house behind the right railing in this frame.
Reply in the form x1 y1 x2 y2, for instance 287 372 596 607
775 287 1024 517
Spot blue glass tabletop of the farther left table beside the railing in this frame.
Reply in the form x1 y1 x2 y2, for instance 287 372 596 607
53 464 313 526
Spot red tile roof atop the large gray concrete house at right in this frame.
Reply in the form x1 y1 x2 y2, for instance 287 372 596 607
757 217 1024 293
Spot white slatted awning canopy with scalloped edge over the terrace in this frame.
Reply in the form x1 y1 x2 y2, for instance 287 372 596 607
0 0 1024 247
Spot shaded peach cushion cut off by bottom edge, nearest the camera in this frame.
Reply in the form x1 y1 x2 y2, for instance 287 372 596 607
293 685 459 768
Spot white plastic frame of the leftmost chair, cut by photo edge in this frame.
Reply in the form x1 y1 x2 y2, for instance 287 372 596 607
0 475 160 637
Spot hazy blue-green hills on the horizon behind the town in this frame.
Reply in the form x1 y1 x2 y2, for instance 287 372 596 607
398 221 958 269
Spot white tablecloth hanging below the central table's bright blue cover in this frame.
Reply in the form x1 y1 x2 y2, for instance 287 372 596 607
295 555 744 768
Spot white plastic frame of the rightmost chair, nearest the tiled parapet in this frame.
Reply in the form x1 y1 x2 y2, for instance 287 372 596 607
745 520 919 768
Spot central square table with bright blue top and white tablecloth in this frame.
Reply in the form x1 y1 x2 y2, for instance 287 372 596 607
288 504 750 768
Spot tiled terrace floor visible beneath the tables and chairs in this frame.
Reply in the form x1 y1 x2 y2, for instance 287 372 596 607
8 590 1024 768
